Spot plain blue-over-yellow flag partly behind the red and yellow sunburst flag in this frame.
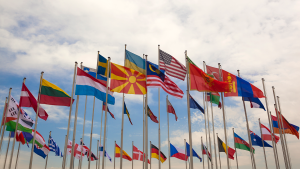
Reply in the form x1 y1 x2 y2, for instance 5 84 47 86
125 50 146 75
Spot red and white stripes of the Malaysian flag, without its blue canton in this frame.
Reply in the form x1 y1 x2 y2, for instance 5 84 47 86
147 75 183 99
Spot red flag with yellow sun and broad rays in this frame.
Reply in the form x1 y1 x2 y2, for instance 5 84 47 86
110 63 147 94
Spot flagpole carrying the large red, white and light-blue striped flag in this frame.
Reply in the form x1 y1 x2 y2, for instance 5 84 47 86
62 62 77 169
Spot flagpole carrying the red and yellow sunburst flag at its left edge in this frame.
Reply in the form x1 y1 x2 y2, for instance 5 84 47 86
102 57 110 169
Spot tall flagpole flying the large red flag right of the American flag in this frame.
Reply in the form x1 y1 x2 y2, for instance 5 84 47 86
185 50 194 169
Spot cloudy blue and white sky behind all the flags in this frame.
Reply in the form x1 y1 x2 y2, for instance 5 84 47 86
0 0 300 169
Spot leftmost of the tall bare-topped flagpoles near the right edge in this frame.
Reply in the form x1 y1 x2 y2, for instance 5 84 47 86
261 78 280 169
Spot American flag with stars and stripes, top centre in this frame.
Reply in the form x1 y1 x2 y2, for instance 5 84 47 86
159 50 186 80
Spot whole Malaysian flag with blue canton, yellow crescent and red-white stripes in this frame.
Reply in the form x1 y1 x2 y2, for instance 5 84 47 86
147 62 183 99
